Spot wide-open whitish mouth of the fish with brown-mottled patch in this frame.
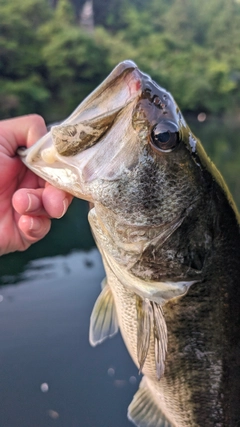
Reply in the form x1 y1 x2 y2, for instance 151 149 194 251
18 60 143 201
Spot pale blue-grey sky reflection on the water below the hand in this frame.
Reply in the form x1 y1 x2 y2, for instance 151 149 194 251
0 249 139 427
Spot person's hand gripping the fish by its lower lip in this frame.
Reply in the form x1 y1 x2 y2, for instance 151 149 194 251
0 115 72 255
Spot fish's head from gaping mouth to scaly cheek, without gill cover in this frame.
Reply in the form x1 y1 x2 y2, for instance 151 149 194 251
19 60 223 224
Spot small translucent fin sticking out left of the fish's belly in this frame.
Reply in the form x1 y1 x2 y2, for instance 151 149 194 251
89 281 118 346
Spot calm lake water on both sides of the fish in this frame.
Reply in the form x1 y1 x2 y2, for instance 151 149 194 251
0 117 240 427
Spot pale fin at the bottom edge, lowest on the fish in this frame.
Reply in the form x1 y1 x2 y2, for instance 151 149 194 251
128 377 172 427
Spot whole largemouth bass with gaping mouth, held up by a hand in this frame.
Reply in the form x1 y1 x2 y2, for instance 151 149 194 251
20 61 240 427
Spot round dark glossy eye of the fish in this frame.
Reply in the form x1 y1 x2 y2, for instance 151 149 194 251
150 122 180 152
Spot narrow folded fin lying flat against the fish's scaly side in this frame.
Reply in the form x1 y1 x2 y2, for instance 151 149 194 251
136 295 167 380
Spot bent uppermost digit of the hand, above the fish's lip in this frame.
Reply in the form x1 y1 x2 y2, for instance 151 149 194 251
0 114 47 156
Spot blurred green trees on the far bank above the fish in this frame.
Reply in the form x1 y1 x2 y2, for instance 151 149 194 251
0 0 240 120
